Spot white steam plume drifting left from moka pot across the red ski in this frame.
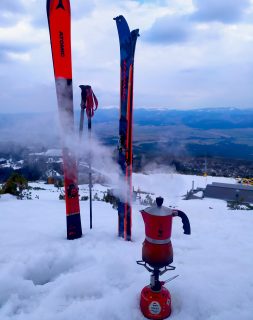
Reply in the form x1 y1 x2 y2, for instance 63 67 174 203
52 79 129 201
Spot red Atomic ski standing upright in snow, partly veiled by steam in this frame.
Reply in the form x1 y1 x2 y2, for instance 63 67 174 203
47 0 82 239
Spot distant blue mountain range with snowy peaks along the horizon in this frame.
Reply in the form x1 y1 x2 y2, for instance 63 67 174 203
0 108 253 130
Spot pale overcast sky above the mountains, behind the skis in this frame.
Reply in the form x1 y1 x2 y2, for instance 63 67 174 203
0 0 253 112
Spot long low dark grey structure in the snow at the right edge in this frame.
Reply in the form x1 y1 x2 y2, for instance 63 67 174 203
203 182 253 203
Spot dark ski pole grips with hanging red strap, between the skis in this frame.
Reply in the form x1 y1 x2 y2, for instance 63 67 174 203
79 85 98 118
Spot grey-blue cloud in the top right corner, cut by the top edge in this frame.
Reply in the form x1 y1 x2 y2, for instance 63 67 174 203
192 0 250 24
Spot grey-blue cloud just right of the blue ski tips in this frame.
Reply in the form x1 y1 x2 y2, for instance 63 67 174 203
142 15 192 44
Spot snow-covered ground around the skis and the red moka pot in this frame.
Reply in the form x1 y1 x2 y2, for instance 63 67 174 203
0 174 253 320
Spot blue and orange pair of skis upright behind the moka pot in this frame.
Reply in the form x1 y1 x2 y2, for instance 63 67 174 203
114 16 139 241
